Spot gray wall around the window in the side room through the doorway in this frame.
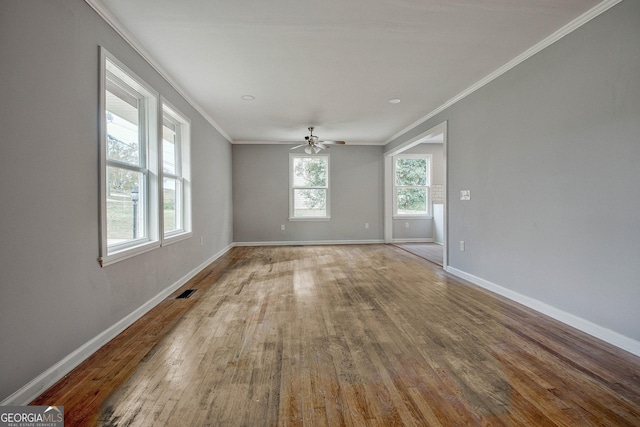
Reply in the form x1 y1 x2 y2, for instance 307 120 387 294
390 143 444 241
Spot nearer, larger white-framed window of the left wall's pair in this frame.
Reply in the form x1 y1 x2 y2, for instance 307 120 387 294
100 49 159 265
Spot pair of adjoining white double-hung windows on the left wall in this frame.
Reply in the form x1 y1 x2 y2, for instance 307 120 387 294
99 49 191 266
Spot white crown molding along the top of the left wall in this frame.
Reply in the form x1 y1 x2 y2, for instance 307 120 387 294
85 0 232 142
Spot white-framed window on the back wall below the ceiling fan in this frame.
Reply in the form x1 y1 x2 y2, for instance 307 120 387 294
289 154 330 219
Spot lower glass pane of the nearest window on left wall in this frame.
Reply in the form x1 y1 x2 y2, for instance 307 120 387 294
107 166 147 246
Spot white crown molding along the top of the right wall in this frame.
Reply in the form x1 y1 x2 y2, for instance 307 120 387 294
384 0 622 145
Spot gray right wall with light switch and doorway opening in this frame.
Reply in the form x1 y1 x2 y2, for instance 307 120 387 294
385 0 640 340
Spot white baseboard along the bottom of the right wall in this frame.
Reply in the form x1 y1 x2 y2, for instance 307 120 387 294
445 267 640 356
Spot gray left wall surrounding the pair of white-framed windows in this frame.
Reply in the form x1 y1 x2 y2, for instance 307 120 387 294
0 0 232 400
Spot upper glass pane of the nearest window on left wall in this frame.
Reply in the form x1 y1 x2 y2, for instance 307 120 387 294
106 84 140 165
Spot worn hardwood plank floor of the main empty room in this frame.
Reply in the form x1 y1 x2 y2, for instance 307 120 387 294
34 245 640 427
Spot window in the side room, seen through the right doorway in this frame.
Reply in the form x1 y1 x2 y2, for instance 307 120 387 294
394 154 431 217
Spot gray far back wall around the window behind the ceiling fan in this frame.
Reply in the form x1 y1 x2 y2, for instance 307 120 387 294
233 145 384 243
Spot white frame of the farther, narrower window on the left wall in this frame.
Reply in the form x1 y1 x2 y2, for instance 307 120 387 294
158 98 193 246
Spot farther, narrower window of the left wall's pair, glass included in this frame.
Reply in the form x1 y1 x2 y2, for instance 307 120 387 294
162 101 191 241
